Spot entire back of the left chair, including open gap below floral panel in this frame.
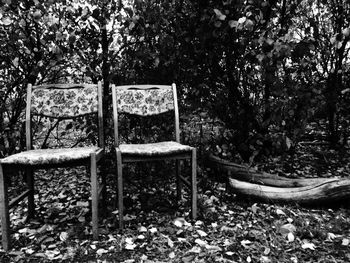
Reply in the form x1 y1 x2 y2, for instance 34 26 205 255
26 83 103 149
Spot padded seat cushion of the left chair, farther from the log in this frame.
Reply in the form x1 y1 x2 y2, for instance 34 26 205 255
0 147 100 165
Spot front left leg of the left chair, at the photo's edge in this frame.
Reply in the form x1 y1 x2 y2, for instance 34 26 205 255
0 164 11 251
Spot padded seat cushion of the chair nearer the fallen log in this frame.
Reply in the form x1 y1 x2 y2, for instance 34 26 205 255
119 141 193 156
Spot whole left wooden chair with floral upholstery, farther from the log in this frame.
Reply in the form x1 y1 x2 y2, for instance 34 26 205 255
0 82 105 250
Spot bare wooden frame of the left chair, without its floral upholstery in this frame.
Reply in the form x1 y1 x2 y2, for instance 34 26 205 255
0 82 106 251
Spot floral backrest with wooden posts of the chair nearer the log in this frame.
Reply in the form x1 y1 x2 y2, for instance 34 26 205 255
112 84 180 146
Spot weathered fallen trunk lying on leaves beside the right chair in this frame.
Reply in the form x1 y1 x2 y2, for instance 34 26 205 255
207 155 350 205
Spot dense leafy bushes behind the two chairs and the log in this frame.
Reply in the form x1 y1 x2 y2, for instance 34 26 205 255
0 0 350 162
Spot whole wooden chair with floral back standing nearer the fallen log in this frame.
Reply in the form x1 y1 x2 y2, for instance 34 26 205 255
112 84 197 229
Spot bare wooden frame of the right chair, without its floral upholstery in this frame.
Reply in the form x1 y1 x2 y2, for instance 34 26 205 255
112 83 197 230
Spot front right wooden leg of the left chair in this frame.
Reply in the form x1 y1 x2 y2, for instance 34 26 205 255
90 153 99 240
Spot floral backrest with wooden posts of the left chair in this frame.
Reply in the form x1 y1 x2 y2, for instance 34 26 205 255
26 82 104 150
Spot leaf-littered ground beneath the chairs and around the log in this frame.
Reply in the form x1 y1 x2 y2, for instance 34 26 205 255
0 145 350 263
